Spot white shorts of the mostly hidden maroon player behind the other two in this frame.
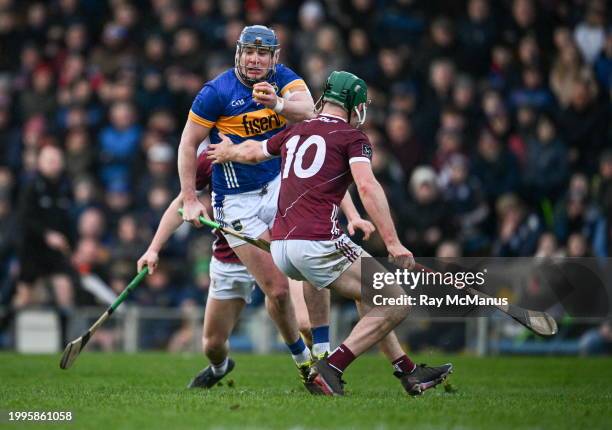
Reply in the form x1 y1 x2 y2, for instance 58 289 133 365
208 257 255 303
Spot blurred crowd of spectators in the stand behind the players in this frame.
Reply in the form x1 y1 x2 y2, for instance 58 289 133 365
0 0 612 352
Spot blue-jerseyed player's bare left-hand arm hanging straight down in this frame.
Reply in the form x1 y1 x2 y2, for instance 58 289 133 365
178 119 210 227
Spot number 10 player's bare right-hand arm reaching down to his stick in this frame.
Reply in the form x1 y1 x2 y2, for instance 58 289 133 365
351 162 414 269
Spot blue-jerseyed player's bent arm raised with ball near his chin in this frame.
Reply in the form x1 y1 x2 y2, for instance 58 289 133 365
253 82 315 122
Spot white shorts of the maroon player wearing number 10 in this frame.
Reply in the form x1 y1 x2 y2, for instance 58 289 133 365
270 234 363 289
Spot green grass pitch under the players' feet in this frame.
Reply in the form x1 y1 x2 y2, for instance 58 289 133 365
0 352 612 430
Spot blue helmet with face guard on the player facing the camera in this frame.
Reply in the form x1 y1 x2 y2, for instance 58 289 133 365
234 25 280 86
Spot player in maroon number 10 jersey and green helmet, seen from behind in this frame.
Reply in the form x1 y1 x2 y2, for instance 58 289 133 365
208 72 452 395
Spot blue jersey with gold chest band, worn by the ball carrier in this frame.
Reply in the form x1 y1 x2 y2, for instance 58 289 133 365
189 64 306 195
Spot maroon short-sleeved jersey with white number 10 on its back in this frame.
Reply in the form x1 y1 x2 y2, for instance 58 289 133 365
263 115 372 240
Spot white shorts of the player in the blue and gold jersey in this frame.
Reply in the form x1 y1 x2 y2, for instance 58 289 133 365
212 174 280 248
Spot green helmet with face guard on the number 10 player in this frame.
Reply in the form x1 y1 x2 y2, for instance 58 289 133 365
315 71 370 126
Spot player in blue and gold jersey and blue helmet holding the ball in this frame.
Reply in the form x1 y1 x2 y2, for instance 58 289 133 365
178 25 328 390
